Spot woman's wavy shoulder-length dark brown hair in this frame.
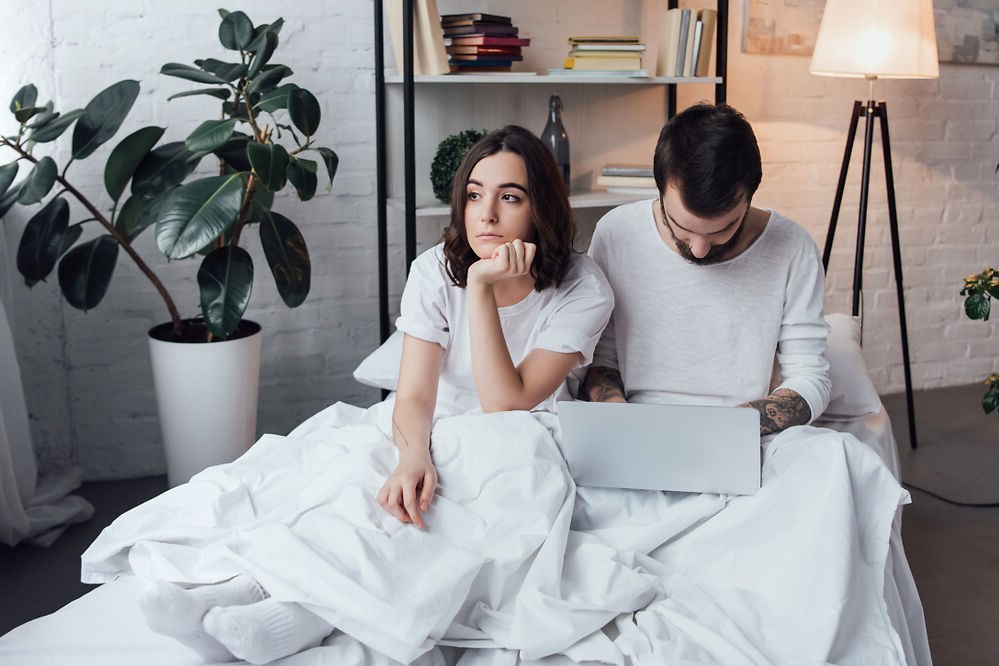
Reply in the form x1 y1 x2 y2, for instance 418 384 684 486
443 125 575 291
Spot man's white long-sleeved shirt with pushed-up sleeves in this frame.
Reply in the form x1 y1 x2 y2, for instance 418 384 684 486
589 201 830 419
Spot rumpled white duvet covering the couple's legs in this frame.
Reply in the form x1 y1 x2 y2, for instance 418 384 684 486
83 402 908 666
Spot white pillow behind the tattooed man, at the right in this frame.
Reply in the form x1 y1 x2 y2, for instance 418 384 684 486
822 312 881 420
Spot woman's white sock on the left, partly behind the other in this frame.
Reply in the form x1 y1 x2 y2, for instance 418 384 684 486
138 576 267 662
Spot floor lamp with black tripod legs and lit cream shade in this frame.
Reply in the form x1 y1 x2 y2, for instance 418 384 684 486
811 0 940 448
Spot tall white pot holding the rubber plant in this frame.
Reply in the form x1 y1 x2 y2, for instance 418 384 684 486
149 322 261 487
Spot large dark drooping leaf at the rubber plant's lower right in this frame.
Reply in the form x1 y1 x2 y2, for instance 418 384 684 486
260 213 312 308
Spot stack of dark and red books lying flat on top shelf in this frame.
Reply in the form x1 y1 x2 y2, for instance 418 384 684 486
441 12 531 74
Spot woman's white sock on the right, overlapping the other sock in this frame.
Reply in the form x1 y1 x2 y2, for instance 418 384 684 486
203 599 333 664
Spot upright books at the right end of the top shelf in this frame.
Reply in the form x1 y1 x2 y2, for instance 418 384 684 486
656 9 718 76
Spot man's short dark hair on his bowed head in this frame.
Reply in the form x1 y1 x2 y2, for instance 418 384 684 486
652 102 763 217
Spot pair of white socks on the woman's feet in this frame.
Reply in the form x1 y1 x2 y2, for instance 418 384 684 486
139 576 333 664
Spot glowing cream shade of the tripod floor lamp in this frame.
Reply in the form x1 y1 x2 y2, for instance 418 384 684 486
810 0 940 79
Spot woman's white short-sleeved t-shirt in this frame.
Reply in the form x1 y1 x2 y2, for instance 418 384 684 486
396 245 614 417
